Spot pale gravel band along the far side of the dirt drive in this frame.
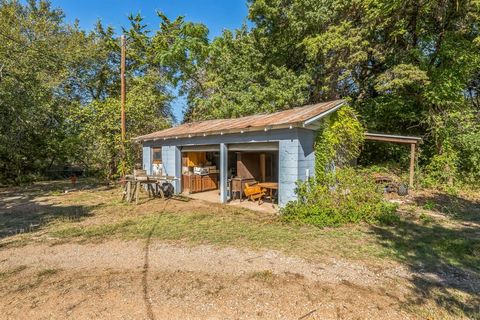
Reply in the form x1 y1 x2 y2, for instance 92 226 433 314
0 241 407 285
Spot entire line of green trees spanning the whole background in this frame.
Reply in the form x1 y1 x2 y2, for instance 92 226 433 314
0 0 480 183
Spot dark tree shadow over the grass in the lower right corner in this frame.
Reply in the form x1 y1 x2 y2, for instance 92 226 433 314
372 219 480 318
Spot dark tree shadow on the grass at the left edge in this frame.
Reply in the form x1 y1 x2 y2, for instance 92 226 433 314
0 182 107 239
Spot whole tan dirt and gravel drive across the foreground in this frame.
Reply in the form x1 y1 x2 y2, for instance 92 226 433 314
0 241 409 319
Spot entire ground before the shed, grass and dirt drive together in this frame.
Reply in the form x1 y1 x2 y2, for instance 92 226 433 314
0 181 480 319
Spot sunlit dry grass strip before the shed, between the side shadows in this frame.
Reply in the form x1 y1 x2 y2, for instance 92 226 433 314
48 200 389 263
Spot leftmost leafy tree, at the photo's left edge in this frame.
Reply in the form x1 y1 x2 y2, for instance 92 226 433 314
0 1 81 182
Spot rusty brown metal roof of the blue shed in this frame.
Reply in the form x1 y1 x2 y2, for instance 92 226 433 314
133 100 345 141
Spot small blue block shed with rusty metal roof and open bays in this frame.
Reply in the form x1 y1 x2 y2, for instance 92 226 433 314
135 100 345 207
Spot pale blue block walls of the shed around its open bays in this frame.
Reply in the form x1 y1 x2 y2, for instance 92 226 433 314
143 128 315 206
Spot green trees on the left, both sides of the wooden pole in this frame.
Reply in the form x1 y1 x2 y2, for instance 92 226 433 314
0 0 208 183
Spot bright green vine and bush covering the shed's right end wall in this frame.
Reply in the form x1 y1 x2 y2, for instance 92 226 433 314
281 106 398 227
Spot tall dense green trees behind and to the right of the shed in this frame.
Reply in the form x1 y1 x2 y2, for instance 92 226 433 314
188 0 480 189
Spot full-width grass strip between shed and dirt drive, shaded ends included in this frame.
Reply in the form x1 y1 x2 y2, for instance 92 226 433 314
0 183 480 271
